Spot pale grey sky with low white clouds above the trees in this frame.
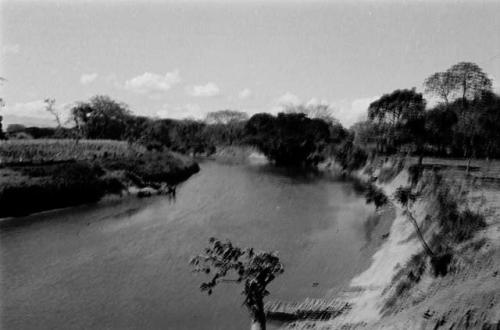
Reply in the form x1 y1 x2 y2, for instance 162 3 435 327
0 0 500 126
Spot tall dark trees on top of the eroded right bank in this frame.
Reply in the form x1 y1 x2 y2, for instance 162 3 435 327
352 62 500 162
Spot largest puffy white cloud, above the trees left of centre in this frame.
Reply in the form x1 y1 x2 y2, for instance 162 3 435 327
124 70 181 94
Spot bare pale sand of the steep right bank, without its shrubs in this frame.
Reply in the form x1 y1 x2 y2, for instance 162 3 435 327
289 159 500 329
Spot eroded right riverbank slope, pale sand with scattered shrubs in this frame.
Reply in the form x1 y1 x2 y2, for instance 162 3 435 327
288 160 500 329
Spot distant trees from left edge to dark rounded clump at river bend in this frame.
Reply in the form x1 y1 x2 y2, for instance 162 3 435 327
3 95 347 166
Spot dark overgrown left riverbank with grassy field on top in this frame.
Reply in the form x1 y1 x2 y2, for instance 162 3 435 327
0 140 199 217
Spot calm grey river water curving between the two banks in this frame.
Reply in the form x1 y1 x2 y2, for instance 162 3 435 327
0 162 382 330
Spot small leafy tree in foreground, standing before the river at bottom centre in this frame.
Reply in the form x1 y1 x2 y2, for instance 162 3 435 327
190 238 284 330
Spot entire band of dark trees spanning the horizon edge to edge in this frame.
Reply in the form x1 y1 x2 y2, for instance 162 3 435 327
1 62 500 170
